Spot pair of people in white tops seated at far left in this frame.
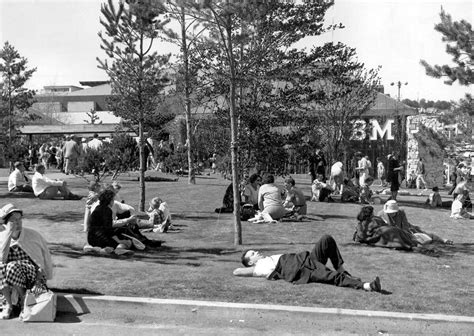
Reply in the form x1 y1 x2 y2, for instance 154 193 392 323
8 162 82 200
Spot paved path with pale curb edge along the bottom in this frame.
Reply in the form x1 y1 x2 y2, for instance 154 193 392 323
0 294 474 336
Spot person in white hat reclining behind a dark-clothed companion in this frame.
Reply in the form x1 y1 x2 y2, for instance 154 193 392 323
377 200 453 245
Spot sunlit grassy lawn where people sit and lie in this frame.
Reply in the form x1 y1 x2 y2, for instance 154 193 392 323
0 169 474 316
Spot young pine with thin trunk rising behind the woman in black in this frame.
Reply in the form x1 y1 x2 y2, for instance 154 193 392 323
97 0 170 211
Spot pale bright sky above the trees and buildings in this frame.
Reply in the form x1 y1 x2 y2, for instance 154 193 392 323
0 0 473 101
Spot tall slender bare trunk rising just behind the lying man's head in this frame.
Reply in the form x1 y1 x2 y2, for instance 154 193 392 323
227 17 242 245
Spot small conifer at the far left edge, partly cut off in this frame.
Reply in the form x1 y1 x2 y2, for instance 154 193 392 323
0 42 36 166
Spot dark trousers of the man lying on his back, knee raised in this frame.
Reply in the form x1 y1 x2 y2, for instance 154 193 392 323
305 235 363 289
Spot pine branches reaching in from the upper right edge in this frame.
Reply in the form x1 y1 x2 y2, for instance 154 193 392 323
420 9 474 85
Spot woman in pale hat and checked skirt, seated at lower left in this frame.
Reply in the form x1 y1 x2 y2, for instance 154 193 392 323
0 204 53 320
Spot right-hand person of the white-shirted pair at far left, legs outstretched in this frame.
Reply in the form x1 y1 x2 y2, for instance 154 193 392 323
32 164 82 200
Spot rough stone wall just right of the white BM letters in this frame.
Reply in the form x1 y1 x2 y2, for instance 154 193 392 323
406 115 444 188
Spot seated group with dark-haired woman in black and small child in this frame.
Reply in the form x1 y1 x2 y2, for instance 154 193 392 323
84 182 172 255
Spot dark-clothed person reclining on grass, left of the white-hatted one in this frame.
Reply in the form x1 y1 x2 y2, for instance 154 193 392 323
353 205 418 251
